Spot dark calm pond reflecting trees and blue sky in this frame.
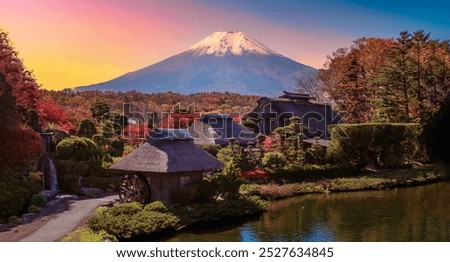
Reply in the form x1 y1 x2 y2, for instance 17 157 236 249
162 181 450 242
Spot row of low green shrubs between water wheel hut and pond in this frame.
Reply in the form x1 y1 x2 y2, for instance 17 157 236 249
88 196 267 240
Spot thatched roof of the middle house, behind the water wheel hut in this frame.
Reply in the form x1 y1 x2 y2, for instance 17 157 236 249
187 114 257 146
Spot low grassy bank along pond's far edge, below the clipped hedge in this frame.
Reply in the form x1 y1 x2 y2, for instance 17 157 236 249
241 164 448 200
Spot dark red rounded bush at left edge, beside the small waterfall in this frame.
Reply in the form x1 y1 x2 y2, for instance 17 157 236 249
0 127 42 166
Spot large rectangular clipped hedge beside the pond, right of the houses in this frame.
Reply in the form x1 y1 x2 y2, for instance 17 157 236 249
327 123 420 168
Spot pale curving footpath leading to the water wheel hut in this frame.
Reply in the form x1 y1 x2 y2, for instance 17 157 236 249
0 195 118 242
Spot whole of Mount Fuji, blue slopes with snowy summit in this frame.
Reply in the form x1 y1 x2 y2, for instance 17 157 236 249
76 31 317 96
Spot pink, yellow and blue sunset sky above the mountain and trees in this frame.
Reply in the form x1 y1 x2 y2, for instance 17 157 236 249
0 0 450 90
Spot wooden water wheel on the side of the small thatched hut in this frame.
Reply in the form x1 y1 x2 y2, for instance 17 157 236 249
119 174 150 203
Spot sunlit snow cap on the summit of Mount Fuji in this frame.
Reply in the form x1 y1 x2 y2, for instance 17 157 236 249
188 31 278 56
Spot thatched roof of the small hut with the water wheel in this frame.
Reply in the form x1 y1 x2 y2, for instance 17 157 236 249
111 129 223 173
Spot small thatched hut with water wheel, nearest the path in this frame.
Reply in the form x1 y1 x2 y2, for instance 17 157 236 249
111 129 223 202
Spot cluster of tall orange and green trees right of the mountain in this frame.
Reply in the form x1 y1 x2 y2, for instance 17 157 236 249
317 30 450 123
